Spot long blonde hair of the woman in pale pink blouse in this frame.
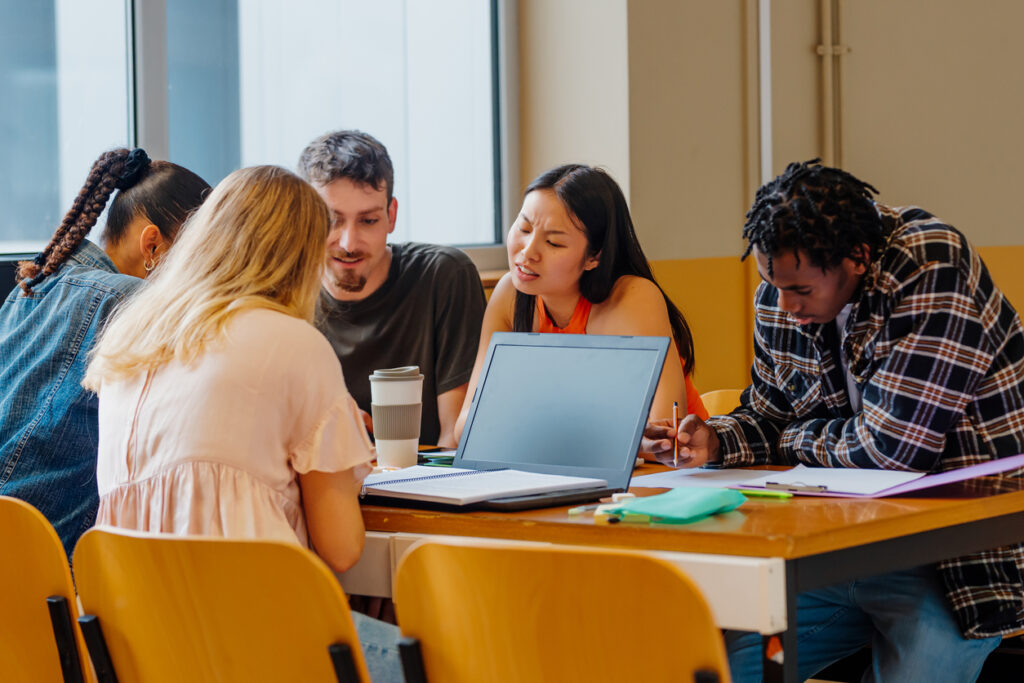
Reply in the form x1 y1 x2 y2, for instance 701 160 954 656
88 166 329 391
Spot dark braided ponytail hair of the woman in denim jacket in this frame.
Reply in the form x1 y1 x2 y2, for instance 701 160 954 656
17 147 210 294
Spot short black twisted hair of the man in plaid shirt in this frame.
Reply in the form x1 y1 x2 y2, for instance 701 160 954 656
741 159 890 275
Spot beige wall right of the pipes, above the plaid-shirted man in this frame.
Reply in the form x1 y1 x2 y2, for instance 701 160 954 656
841 0 1024 246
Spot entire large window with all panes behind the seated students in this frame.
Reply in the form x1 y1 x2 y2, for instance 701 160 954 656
0 0 512 252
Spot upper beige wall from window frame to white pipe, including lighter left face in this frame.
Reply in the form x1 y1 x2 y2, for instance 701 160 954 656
518 0 759 259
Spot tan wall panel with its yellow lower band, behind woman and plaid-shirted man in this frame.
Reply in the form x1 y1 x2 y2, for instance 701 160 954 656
629 0 759 390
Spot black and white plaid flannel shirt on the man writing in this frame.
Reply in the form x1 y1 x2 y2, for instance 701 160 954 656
709 205 1024 638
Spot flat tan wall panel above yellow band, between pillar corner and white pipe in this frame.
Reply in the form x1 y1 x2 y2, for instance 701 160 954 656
629 0 758 260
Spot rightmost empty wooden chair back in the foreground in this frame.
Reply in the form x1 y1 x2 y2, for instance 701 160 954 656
394 540 729 683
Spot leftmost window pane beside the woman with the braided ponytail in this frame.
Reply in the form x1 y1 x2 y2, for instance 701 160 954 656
0 0 130 253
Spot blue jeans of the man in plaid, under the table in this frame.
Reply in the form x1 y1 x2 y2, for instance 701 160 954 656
725 565 1000 683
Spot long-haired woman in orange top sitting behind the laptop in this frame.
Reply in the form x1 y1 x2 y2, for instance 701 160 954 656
456 164 708 446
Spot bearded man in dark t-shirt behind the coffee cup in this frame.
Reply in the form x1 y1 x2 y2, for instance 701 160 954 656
298 130 486 447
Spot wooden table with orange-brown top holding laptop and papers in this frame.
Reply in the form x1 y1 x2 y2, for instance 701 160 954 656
341 465 1024 682
